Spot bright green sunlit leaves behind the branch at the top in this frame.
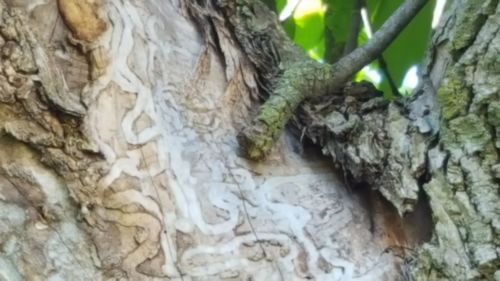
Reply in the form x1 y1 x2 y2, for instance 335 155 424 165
267 0 435 97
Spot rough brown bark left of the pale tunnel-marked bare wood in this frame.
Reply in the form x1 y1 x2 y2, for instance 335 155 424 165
0 2 103 280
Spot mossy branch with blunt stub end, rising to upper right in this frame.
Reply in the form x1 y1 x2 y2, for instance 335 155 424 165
238 0 428 160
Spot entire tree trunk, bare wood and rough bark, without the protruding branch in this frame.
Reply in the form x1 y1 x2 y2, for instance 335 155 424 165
0 0 500 280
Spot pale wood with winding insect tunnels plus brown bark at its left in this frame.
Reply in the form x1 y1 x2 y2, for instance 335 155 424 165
0 0 407 280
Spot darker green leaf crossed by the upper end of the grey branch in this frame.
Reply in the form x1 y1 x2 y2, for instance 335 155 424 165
366 0 434 96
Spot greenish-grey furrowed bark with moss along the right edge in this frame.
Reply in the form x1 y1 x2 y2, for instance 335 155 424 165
414 1 500 280
